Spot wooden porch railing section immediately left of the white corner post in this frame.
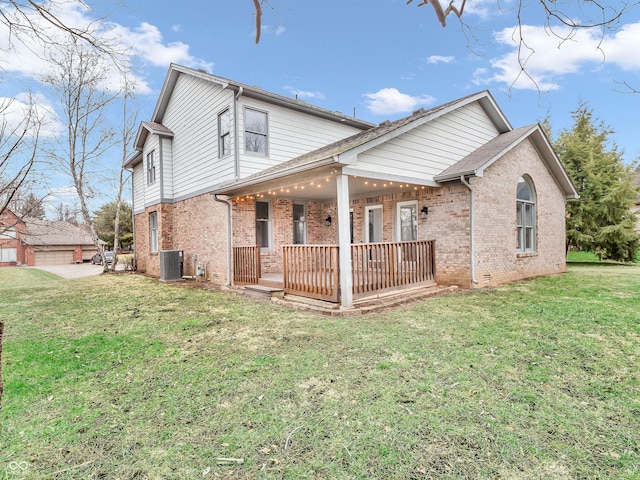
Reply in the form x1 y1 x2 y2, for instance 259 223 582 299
282 245 340 302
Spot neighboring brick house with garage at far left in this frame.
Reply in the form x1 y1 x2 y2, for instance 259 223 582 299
0 210 98 266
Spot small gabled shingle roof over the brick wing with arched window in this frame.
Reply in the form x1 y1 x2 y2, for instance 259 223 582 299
434 124 578 198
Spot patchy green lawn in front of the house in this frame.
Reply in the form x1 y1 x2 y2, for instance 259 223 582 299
0 264 640 479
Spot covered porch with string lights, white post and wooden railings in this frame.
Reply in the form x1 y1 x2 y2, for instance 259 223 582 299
220 165 436 309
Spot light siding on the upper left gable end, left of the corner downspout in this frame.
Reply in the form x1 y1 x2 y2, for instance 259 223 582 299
162 75 234 198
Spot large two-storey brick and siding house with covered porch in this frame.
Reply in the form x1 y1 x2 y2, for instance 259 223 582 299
125 65 577 309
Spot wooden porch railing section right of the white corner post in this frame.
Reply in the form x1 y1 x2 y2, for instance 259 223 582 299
351 240 435 296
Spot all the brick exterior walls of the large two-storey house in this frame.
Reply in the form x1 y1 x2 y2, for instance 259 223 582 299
135 141 566 288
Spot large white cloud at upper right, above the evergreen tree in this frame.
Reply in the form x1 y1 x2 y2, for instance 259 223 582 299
474 23 640 90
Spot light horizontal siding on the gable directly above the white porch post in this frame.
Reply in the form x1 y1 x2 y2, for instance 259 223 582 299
351 103 499 180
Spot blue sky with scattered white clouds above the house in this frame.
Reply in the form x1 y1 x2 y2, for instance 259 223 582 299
0 0 640 210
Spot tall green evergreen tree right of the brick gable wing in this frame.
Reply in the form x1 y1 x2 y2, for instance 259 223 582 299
554 103 639 261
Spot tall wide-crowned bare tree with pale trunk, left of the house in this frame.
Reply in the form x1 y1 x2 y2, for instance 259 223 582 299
43 36 120 271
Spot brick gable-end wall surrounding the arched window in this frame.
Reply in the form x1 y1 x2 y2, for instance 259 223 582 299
473 141 566 287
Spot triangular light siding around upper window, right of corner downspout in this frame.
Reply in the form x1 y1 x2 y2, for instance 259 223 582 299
238 97 360 177
